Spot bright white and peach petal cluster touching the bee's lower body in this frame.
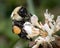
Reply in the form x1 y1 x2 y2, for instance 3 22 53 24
23 22 39 38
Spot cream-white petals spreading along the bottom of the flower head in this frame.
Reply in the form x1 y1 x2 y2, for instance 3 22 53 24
32 36 55 48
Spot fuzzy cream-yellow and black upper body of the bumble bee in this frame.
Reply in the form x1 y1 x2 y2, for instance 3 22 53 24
11 6 29 21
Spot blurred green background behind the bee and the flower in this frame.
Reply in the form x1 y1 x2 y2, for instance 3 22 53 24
0 0 60 48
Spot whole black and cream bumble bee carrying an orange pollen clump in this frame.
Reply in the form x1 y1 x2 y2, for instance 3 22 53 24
11 6 32 40
